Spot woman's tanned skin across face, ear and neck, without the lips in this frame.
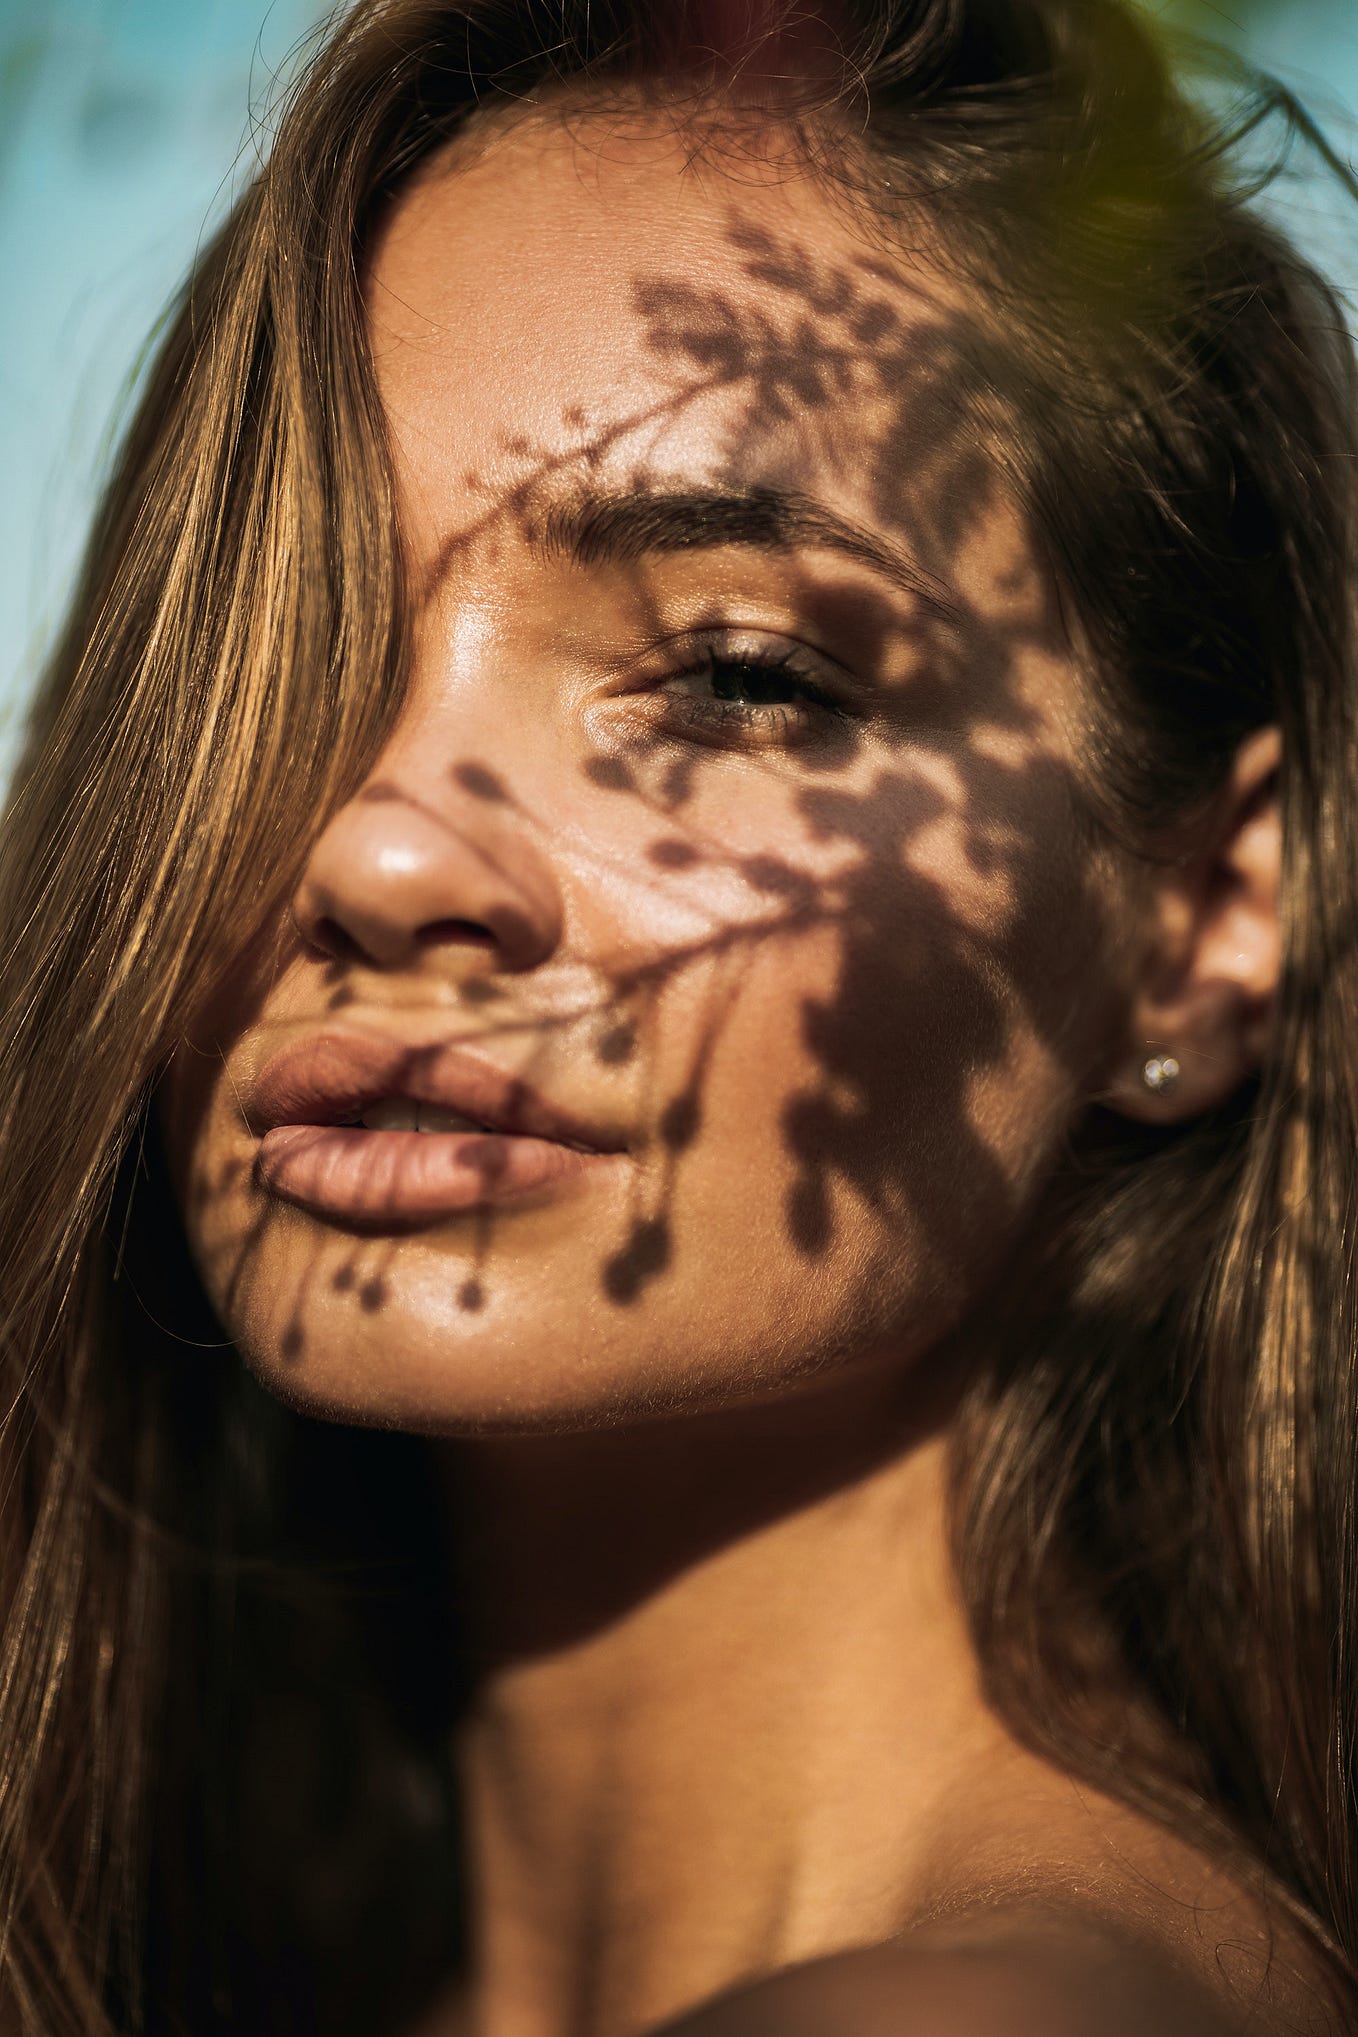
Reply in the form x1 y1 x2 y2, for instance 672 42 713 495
151 118 1303 2037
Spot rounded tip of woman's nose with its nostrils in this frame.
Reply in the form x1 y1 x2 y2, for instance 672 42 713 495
293 766 562 970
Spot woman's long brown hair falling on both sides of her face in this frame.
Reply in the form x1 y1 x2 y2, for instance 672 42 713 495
0 0 1358 2037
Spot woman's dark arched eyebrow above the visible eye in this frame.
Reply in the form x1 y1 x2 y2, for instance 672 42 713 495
533 487 963 629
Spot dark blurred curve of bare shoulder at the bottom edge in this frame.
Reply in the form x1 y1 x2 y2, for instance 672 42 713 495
654 1923 1272 2037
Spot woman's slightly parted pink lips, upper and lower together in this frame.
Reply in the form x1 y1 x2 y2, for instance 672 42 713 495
244 1033 627 1230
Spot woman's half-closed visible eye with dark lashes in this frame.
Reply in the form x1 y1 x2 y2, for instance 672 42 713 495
656 636 849 750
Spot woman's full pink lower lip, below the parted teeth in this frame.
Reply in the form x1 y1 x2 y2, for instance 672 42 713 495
254 1124 619 1224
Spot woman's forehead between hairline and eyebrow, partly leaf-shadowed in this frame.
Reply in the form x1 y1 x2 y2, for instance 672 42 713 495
369 116 1016 590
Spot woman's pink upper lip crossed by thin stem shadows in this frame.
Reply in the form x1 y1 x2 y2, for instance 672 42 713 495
242 1029 627 1153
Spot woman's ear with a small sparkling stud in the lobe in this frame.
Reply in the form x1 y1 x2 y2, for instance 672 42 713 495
1104 727 1283 1124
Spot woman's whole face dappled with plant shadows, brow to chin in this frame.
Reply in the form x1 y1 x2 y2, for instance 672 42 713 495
163 120 1124 1432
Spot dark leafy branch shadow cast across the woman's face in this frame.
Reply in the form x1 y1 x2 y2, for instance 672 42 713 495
260 218 1095 1355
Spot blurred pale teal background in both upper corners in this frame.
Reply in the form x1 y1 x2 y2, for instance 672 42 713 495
0 0 1358 786
